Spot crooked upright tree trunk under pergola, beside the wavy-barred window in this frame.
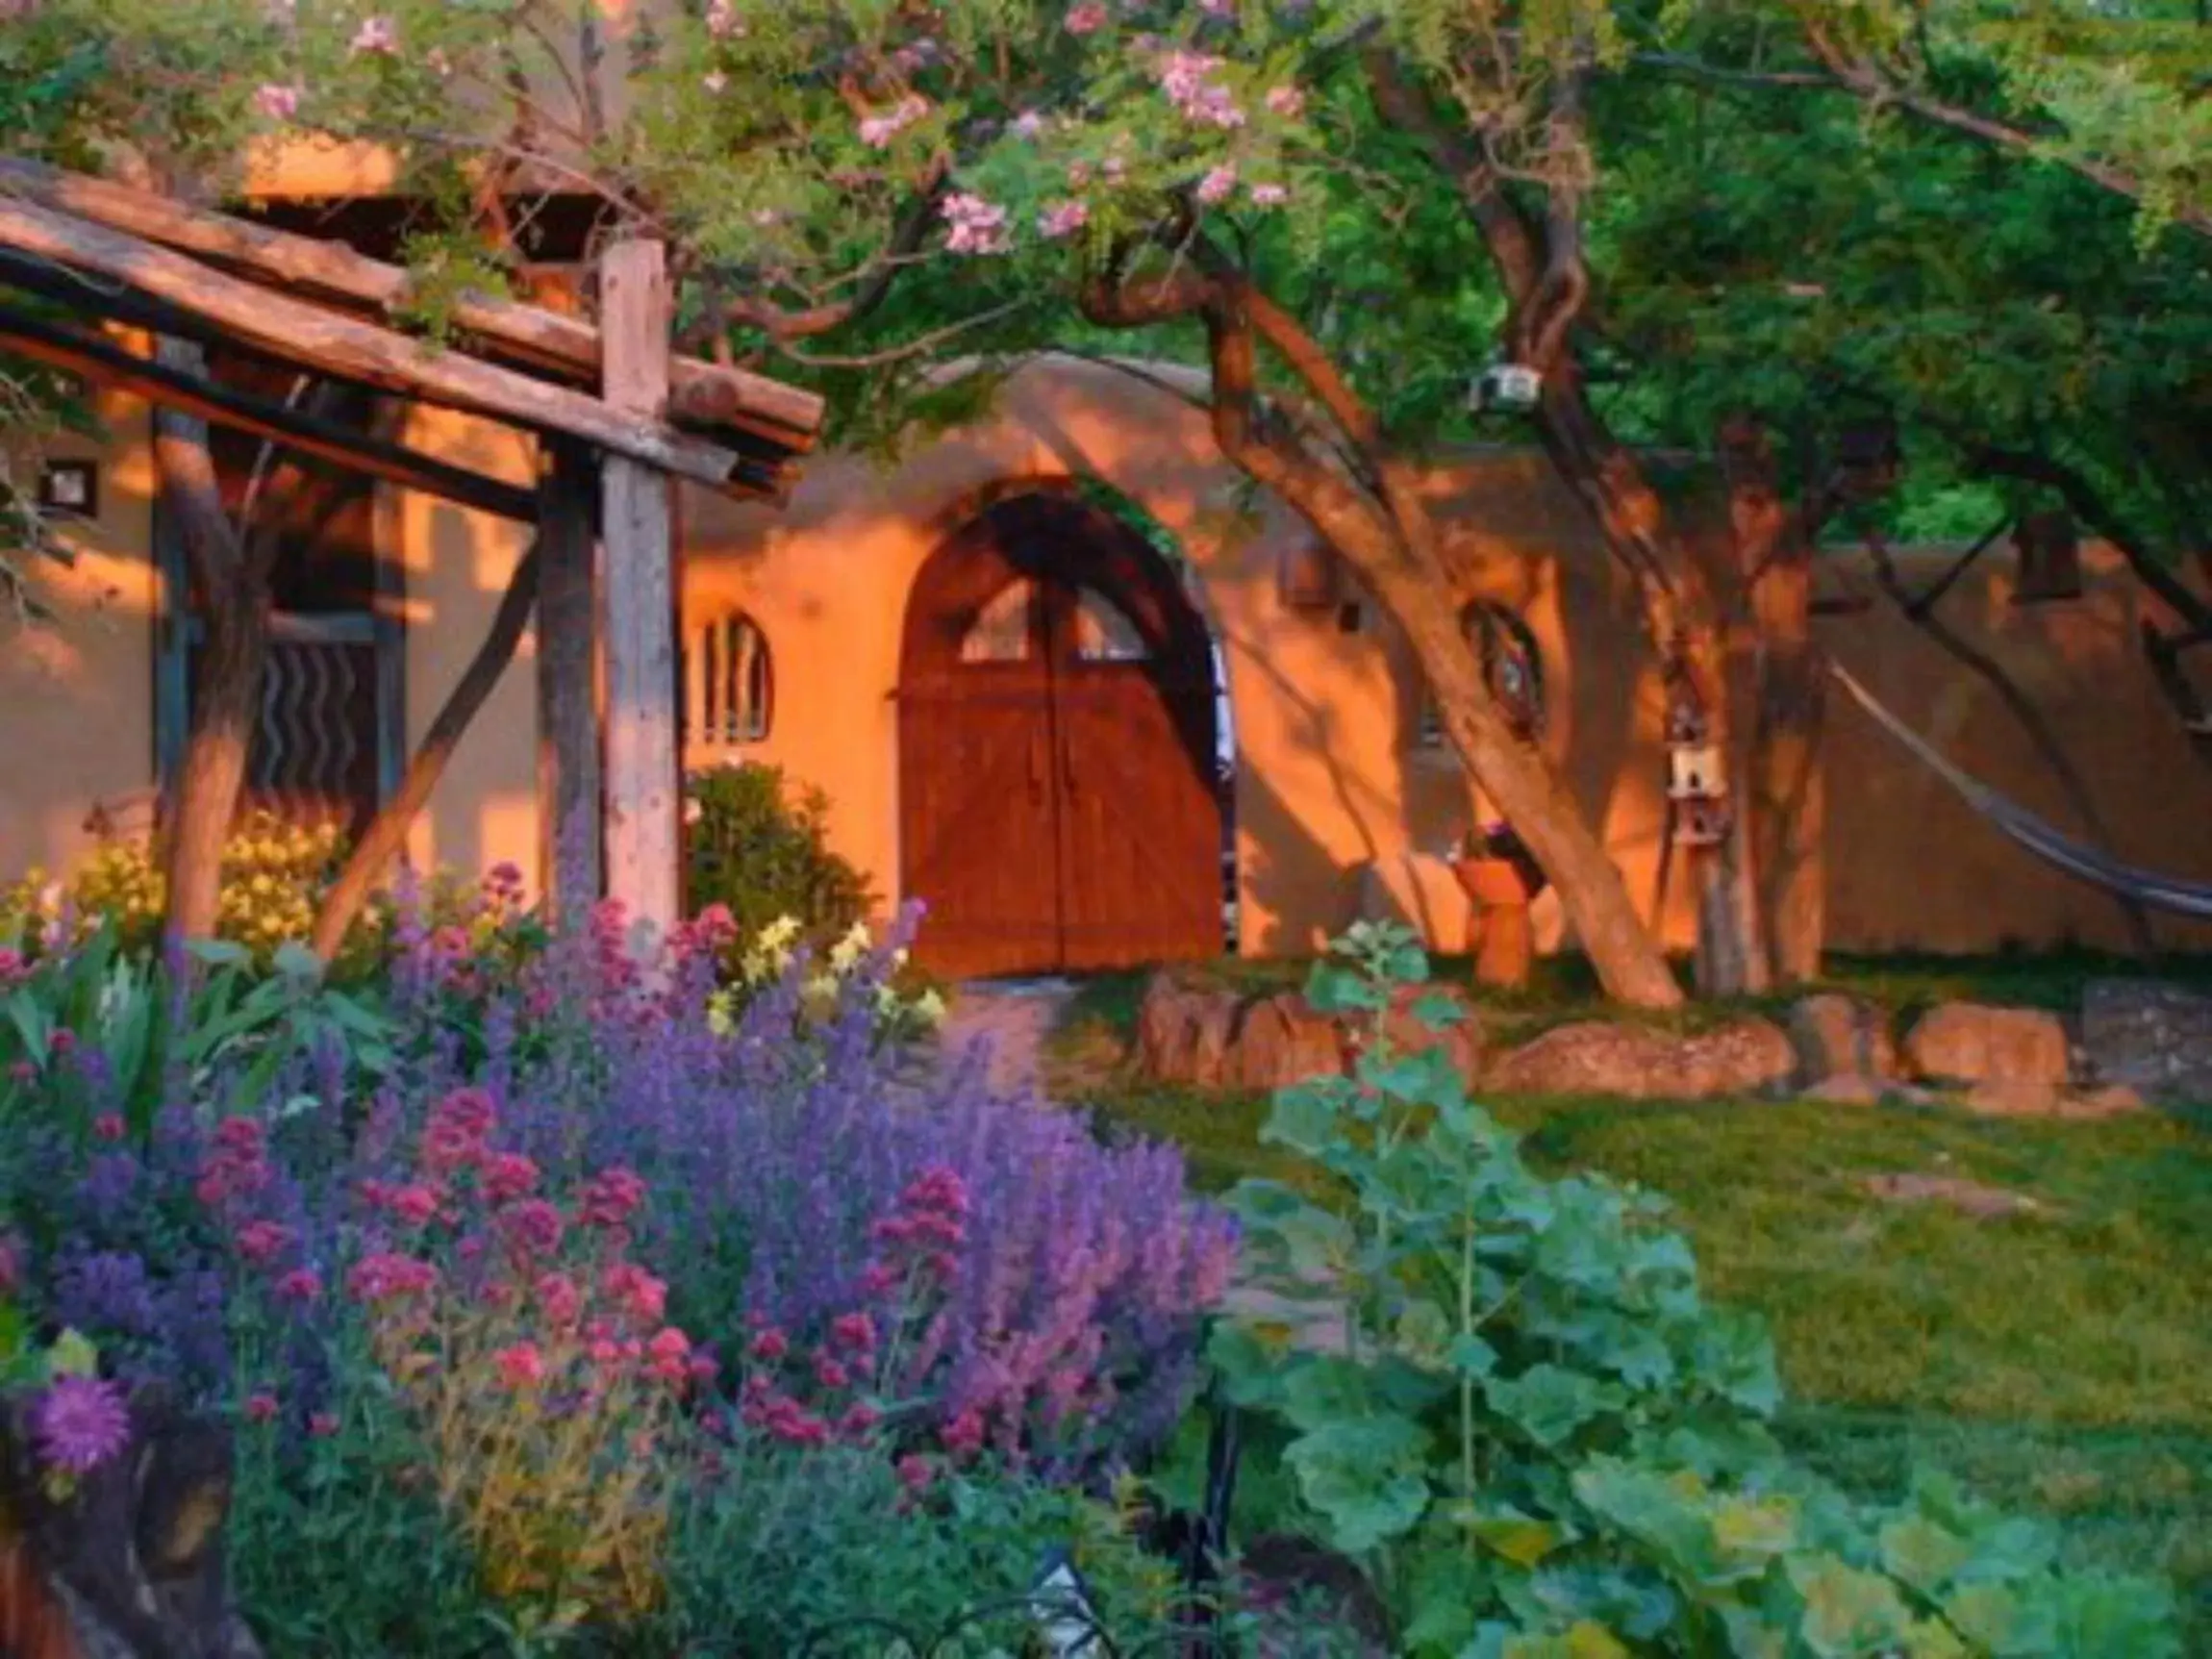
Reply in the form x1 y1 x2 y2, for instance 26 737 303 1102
153 340 270 943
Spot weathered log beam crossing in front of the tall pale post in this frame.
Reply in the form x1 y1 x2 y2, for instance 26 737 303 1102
0 194 739 489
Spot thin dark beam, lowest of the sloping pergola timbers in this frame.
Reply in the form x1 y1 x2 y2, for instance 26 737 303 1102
0 305 538 522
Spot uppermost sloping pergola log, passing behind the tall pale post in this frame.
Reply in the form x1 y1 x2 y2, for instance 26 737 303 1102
0 157 823 451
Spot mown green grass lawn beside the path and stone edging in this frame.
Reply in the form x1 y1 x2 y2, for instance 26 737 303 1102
1057 963 2212 1654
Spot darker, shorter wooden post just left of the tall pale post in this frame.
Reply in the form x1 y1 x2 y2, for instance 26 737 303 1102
538 444 602 924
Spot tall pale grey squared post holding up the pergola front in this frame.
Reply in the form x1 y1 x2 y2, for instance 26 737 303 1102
599 241 681 955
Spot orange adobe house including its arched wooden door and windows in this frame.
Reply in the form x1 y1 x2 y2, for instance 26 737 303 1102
0 332 2212 971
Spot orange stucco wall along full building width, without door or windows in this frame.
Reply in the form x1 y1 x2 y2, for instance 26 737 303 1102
0 361 2212 953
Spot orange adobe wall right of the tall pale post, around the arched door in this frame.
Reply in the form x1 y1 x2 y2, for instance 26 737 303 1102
686 361 2212 953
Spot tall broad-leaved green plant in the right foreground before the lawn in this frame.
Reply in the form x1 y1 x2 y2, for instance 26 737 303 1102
1215 924 2179 1659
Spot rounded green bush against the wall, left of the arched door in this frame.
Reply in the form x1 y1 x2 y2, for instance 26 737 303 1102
684 766 876 944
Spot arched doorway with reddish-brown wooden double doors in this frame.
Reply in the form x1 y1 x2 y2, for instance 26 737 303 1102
898 493 1221 978
